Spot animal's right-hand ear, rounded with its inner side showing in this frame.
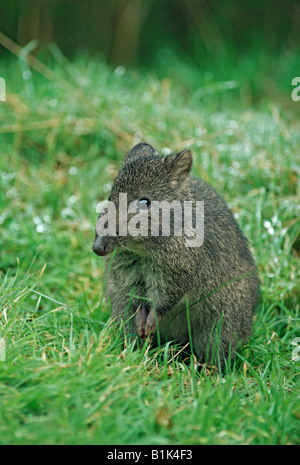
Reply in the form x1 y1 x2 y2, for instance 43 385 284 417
165 149 193 187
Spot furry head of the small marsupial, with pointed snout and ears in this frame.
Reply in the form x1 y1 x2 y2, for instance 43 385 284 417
93 143 192 256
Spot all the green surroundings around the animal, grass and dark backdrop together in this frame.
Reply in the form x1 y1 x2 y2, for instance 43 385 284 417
0 0 300 444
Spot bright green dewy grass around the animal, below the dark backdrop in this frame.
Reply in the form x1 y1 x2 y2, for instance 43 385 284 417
0 49 300 445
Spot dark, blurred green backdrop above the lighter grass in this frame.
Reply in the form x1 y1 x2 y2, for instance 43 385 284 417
0 0 300 104
